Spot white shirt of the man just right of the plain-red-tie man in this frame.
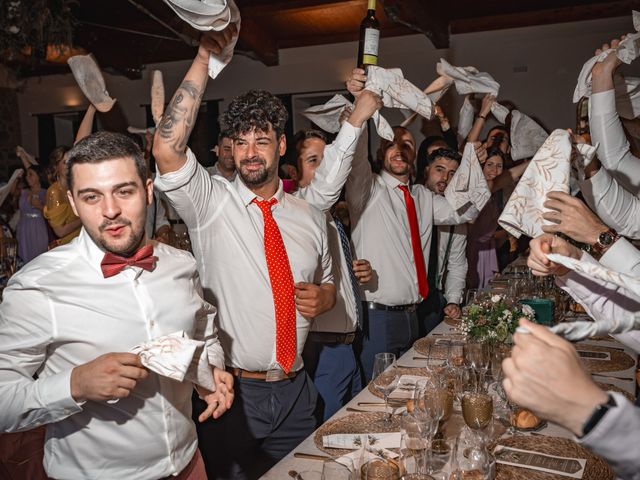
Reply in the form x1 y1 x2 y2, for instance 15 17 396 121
437 224 468 305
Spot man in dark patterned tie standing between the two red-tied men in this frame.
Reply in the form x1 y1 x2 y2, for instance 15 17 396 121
296 126 371 422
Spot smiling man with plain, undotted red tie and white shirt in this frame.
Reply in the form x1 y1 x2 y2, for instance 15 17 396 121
346 69 487 380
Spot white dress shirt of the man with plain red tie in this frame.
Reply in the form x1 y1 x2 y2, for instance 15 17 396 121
347 148 479 305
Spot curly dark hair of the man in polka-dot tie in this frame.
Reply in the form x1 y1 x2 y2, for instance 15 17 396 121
220 90 289 138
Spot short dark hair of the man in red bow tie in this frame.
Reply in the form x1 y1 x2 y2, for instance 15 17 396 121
67 132 147 192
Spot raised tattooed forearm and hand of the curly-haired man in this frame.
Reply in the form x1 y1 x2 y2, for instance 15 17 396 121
153 24 236 174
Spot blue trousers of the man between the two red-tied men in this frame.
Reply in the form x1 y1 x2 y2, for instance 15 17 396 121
302 339 362 425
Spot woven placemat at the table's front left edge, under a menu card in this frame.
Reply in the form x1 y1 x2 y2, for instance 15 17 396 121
313 412 400 456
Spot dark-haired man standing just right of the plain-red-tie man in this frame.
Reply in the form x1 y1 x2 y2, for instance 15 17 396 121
417 148 468 336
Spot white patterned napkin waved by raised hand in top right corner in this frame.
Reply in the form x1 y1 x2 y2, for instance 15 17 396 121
573 10 640 119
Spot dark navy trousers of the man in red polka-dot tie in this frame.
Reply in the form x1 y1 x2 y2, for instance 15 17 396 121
193 371 317 480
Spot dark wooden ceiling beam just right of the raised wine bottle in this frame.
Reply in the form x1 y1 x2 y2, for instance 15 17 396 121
380 0 449 48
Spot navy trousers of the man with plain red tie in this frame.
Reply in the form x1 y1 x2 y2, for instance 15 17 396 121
360 303 418 384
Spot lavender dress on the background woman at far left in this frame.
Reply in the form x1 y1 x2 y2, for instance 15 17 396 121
16 189 49 263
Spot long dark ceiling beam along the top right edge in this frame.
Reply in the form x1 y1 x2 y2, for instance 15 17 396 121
451 0 640 34
